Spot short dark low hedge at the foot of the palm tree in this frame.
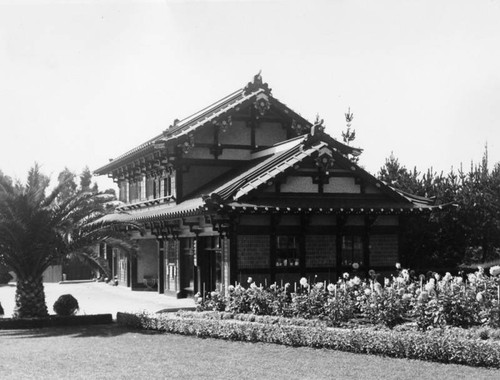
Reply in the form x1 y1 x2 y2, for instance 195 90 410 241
0 314 113 330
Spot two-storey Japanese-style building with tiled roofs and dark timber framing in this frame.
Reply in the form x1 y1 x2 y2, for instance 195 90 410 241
95 75 439 297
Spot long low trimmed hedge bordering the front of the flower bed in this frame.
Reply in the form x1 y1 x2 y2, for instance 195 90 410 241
117 313 500 368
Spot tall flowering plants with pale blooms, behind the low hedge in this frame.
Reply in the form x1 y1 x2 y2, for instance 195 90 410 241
197 265 500 331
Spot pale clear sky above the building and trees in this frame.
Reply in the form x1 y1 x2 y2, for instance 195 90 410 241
0 0 500 188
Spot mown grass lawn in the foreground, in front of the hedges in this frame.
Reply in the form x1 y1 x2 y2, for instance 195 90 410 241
0 325 500 380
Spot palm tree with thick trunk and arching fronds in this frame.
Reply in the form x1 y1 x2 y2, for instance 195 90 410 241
0 164 136 318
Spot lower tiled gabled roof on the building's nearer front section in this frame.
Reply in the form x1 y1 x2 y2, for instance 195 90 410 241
97 126 446 222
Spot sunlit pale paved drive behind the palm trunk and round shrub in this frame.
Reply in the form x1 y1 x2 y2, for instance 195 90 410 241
0 282 195 318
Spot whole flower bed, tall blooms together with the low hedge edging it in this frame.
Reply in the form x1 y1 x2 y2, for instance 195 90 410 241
117 264 500 368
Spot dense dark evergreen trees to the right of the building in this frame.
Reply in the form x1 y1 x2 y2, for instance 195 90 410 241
378 150 500 268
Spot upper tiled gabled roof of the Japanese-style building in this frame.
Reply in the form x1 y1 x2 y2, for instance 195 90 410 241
94 73 361 175
